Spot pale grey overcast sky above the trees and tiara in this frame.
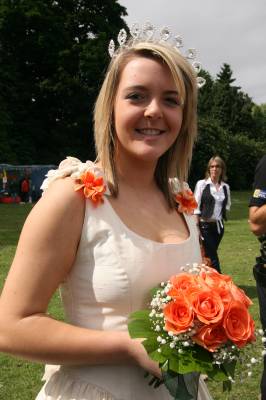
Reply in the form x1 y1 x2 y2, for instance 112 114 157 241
119 0 266 104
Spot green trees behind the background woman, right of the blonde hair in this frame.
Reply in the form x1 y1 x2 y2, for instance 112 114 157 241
193 64 266 189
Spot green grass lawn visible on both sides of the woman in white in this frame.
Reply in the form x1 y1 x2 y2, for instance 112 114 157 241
0 192 261 400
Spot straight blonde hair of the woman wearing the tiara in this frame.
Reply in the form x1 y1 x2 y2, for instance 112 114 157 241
94 42 197 208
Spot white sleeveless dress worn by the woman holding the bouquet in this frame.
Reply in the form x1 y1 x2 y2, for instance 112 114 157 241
36 159 211 400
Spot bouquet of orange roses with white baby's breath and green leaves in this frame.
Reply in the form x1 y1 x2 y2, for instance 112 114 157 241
128 264 255 400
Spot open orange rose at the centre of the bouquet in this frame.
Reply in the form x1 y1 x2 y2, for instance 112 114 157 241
191 289 224 325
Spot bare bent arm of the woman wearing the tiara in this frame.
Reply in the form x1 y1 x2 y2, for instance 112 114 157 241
0 178 159 375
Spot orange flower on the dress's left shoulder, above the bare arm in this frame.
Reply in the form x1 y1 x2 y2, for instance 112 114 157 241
75 171 106 206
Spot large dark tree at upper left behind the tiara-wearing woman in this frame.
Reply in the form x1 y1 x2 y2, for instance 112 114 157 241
0 0 126 163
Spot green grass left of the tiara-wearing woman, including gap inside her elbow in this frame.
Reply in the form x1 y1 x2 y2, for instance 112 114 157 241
0 204 63 400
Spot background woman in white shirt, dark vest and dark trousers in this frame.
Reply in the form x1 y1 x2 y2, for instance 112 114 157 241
194 155 231 273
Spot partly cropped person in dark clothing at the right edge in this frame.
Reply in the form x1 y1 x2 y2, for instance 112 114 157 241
249 155 266 400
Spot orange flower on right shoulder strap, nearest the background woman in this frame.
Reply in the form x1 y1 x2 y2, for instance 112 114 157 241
170 178 198 214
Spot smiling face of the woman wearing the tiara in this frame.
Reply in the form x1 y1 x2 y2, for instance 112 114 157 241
114 57 183 164
